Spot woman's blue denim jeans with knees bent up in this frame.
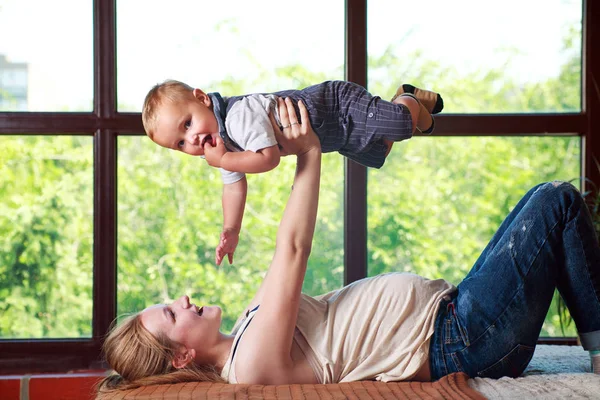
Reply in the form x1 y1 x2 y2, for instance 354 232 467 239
429 182 600 380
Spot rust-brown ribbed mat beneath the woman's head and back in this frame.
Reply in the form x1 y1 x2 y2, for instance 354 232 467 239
98 373 485 400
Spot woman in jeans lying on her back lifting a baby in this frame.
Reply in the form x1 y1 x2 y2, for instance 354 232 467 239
100 97 600 392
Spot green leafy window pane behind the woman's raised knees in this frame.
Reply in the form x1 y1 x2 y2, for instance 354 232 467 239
368 137 581 336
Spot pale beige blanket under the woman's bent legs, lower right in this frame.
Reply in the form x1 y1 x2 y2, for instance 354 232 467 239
469 345 600 400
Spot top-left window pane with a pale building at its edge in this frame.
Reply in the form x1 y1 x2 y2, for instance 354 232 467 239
0 0 93 111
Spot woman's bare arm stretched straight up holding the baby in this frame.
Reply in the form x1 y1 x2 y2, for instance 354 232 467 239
235 99 321 384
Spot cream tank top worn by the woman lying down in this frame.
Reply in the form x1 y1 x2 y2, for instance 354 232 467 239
221 272 456 383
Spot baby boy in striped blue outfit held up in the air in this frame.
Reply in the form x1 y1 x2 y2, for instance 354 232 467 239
142 80 444 265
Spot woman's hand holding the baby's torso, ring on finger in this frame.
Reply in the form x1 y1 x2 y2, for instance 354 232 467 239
271 98 321 156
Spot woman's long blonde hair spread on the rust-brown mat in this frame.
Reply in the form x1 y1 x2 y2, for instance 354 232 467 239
97 313 225 399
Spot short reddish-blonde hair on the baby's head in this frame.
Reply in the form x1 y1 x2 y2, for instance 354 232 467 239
142 79 194 140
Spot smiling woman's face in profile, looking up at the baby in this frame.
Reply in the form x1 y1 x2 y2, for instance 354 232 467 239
140 295 221 358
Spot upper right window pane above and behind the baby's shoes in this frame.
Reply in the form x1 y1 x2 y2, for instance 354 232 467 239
367 0 582 113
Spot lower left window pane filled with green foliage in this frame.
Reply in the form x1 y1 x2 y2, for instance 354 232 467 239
0 136 94 339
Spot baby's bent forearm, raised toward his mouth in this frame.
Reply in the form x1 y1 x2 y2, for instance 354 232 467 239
221 145 281 174
